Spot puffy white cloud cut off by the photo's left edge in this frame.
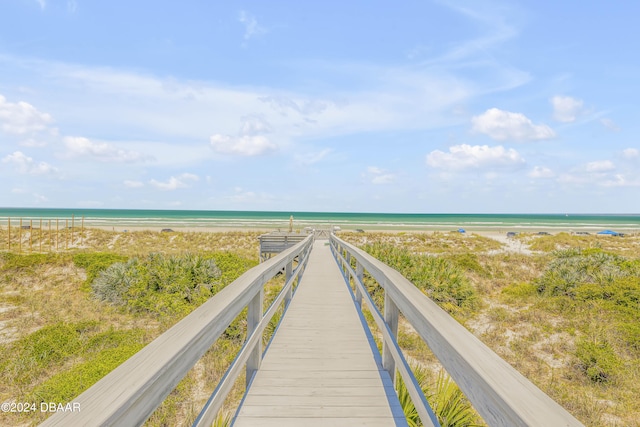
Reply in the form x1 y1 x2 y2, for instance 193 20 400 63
0 95 53 135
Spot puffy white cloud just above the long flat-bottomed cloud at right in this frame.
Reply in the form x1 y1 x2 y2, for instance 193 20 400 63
471 108 556 141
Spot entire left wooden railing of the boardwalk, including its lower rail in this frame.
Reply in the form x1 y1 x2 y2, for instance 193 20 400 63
42 236 313 427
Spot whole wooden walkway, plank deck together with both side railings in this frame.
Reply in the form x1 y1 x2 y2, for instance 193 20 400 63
42 235 582 427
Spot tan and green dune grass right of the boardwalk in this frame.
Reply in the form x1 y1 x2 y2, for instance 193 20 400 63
341 233 640 426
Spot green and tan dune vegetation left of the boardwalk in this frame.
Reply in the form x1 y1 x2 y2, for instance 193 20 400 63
0 230 262 426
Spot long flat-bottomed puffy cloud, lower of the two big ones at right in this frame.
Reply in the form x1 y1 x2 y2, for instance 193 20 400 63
427 144 525 170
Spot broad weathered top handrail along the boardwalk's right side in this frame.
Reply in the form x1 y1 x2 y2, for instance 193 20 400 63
331 235 582 427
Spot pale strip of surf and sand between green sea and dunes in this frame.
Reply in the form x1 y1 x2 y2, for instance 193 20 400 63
0 214 640 235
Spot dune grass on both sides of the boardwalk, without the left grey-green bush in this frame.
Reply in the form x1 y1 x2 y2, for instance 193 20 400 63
0 230 640 426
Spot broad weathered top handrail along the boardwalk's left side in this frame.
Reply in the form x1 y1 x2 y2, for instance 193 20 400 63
41 236 313 426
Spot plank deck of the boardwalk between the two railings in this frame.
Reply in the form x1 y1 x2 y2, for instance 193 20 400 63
233 240 407 427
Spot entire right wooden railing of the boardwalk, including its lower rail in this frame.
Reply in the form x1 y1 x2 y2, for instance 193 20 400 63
330 235 582 427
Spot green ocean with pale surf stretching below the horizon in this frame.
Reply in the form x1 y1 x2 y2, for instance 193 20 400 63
0 208 640 232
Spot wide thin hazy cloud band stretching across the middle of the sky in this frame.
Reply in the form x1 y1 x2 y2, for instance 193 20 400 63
5 54 522 152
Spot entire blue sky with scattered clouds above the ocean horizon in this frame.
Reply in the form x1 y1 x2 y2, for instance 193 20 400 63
0 0 640 213
